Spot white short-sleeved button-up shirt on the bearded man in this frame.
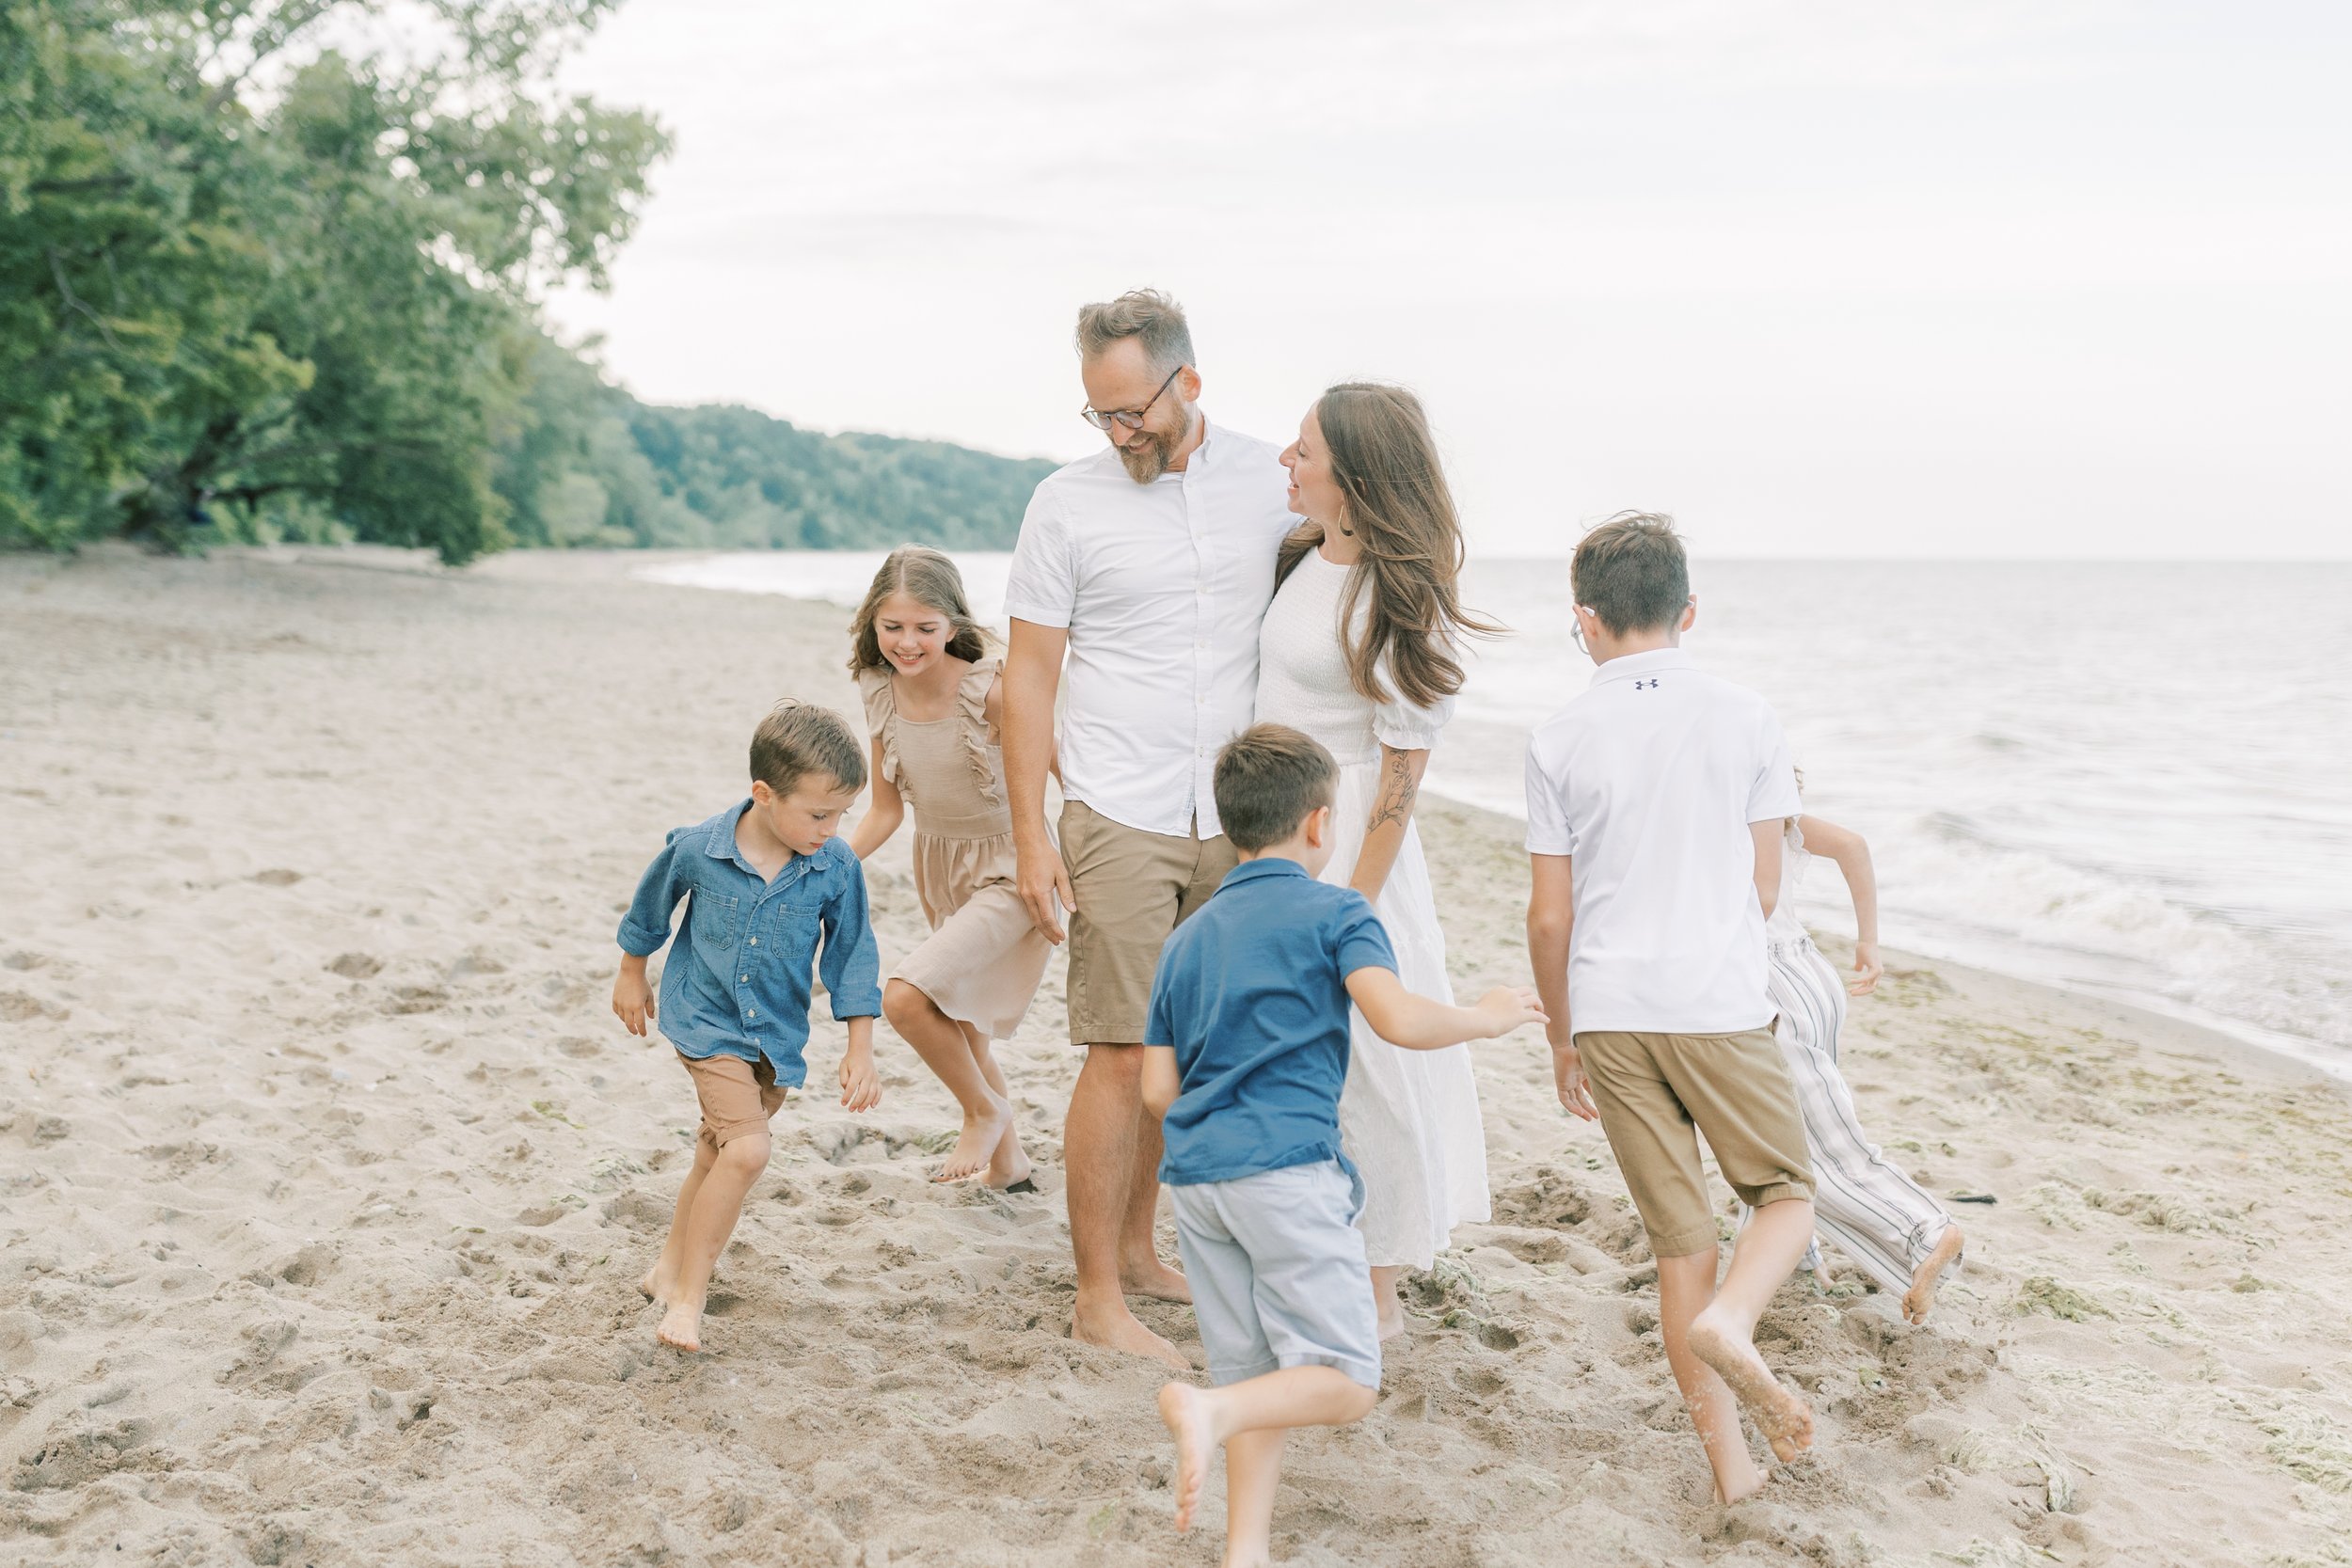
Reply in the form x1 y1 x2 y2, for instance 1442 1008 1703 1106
1005 413 1298 839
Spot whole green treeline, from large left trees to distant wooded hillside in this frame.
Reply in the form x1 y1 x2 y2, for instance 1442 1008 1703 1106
0 0 1044 562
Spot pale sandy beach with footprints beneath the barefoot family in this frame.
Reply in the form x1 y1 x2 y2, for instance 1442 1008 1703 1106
0 550 2352 1568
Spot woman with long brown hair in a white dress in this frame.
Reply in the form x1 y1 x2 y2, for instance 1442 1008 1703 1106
1259 381 1499 1340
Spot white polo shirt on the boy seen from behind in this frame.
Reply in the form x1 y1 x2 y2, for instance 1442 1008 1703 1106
1527 649 1800 1035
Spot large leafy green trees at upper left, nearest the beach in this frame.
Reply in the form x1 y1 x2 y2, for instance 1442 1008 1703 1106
0 0 663 560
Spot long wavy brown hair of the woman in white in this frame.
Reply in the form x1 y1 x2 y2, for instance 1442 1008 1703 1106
1275 381 1503 707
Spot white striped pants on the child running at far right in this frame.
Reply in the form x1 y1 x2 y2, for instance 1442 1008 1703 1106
1740 938 1952 1293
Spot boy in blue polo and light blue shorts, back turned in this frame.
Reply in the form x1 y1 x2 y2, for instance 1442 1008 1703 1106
1143 724 1543 1568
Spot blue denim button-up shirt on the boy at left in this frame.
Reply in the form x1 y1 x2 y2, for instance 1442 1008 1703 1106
619 800 882 1086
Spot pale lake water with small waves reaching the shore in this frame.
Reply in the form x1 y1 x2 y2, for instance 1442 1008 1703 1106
644 552 2352 1074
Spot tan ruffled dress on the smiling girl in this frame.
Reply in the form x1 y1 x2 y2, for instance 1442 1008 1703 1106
859 658 1054 1039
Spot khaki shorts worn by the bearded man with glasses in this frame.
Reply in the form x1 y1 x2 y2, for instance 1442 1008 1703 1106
1061 800 1237 1046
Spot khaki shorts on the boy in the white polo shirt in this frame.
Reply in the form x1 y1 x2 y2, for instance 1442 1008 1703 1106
1576 1030 1814 1258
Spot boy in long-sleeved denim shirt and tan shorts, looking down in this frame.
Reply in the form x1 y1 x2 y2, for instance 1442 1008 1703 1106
612 701 882 1350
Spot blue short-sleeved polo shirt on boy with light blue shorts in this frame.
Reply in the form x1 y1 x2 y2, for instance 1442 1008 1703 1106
1143 858 1397 1187
